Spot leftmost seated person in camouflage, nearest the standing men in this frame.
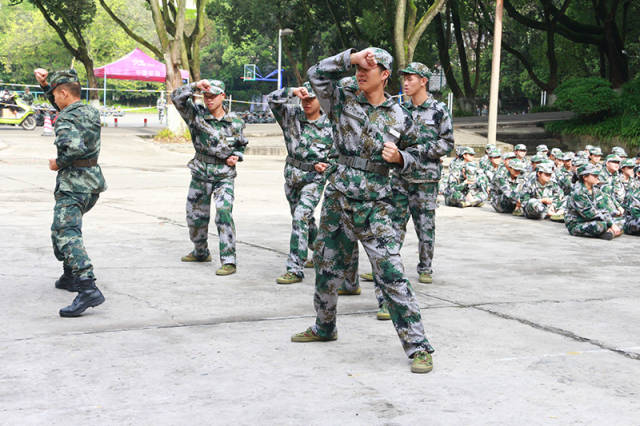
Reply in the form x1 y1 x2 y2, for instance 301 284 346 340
444 162 487 207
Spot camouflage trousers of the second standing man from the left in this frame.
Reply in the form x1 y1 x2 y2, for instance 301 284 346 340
187 177 236 265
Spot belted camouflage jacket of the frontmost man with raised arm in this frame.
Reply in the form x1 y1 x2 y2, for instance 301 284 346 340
307 49 426 201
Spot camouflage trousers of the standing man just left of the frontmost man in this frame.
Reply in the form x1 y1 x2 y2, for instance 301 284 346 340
284 180 324 277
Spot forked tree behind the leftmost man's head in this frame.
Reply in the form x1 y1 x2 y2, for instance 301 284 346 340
10 0 99 101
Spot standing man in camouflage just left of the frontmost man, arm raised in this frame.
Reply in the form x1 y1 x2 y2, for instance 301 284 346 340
267 83 333 284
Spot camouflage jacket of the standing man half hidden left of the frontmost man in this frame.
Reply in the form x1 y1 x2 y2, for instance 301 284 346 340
267 88 333 163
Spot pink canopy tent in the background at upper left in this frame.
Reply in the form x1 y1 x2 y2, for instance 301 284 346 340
93 47 189 82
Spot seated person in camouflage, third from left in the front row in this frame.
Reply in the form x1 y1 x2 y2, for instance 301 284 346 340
518 161 564 220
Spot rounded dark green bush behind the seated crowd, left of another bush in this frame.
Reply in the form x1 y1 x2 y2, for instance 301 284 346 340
555 77 618 120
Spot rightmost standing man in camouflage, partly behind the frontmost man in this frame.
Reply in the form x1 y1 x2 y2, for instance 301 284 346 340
361 62 454 300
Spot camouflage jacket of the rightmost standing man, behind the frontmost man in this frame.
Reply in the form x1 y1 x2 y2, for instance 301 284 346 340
400 97 454 182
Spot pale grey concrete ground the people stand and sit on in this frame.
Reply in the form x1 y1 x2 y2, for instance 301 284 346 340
0 123 640 425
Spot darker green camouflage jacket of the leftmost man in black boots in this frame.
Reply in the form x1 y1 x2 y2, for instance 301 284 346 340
42 90 107 194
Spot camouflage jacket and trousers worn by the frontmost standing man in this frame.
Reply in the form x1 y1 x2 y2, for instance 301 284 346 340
307 49 433 357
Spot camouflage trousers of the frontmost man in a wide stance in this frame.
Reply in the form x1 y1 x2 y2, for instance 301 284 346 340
313 185 433 357
